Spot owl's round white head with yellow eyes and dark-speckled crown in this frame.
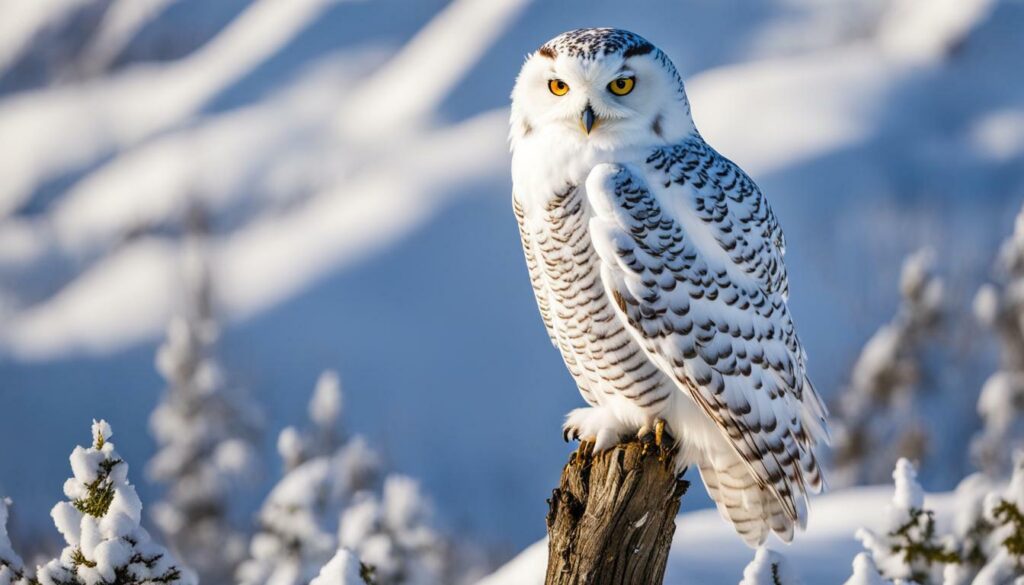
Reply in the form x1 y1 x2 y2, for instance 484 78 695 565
511 29 695 149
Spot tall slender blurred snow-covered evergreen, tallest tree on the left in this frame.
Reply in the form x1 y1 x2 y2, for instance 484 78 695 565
146 207 260 583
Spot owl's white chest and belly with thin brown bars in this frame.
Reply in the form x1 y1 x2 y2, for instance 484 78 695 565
514 135 675 426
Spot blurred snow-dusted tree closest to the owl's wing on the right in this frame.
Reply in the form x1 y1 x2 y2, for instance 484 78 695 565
830 250 945 486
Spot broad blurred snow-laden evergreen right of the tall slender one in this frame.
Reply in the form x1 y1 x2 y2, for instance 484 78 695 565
237 372 454 585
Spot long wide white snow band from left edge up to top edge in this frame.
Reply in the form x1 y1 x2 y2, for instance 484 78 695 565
0 0 336 216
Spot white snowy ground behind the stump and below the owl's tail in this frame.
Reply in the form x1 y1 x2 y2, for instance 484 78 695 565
477 486 953 585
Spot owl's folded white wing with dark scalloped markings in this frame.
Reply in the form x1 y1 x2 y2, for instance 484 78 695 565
587 142 827 526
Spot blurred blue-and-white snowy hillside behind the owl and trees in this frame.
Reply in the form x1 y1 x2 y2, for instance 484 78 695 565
0 0 1024 577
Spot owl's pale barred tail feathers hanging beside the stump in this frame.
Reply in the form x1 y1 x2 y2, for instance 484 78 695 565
698 451 803 548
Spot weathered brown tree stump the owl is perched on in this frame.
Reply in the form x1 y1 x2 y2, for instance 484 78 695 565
545 441 689 585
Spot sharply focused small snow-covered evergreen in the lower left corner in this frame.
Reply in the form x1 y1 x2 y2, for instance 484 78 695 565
37 421 197 585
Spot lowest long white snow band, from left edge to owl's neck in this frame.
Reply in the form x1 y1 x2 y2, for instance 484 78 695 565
0 106 506 360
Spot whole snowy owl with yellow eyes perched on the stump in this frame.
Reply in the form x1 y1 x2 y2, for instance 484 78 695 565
510 29 827 546
